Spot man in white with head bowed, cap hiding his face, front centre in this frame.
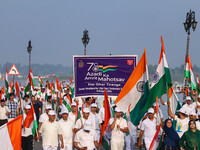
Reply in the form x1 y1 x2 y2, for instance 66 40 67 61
74 120 99 150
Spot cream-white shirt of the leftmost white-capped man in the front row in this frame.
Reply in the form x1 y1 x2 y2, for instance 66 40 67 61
39 121 62 146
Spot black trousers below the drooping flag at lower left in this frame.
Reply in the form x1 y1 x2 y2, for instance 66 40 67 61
22 135 33 150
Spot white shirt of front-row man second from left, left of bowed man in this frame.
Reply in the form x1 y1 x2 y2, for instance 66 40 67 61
58 119 74 144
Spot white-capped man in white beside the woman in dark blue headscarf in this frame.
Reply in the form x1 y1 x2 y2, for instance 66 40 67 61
138 108 156 149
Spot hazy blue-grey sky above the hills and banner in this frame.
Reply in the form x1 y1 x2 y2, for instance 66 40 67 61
0 0 200 67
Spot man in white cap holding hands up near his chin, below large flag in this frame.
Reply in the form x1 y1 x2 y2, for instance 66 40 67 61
109 107 128 150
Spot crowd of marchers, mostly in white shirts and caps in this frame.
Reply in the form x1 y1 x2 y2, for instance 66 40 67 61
0 84 200 150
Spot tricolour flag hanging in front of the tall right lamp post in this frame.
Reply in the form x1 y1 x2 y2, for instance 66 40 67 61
185 54 196 90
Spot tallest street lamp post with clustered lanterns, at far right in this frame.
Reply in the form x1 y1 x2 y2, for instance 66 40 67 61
183 10 197 99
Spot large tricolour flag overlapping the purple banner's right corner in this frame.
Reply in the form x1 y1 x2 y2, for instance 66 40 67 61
115 49 149 126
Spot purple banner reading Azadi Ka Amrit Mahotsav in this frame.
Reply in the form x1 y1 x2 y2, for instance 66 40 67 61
73 55 137 97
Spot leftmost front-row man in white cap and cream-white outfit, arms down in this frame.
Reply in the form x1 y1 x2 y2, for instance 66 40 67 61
37 110 64 150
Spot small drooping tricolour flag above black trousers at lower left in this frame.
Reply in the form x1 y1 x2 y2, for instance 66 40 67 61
23 104 38 135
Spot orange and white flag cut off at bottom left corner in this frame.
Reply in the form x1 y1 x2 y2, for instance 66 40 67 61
0 115 23 150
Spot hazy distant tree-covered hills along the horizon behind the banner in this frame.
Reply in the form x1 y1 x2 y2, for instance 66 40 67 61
0 63 200 82
